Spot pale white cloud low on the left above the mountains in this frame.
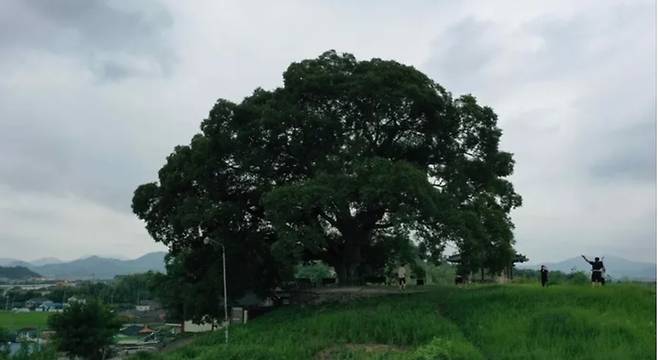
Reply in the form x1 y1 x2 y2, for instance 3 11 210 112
0 187 164 259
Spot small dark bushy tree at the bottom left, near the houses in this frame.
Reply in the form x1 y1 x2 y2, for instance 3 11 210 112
48 301 121 360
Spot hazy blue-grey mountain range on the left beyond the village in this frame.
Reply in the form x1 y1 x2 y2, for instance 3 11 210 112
0 252 166 280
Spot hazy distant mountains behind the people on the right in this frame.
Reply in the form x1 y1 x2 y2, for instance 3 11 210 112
517 256 656 281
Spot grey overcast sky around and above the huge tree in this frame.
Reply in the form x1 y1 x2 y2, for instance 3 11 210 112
0 0 656 263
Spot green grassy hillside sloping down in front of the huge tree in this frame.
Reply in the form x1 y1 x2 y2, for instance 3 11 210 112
139 285 656 360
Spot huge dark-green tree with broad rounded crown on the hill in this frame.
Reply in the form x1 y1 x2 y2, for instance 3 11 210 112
133 51 521 285
